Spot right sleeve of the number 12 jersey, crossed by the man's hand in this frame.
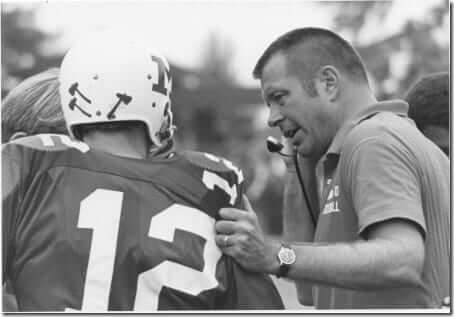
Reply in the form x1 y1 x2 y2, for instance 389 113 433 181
182 152 284 310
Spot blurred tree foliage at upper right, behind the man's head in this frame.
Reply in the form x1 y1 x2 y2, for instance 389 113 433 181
321 0 449 99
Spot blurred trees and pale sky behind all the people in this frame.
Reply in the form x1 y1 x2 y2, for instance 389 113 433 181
1 0 450 235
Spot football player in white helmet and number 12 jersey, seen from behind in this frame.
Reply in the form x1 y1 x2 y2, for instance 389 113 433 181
2 34 283 312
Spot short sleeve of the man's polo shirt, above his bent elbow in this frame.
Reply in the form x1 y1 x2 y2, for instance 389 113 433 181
344 134 426 233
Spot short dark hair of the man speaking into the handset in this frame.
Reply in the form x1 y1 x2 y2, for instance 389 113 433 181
253 27 368 87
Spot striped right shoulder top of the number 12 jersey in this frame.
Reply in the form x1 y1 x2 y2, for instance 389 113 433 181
182 151 244 184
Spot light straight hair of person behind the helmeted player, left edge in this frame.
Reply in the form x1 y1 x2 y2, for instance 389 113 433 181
2 68 67 143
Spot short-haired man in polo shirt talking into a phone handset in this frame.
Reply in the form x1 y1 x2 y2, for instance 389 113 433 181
216 28 450 309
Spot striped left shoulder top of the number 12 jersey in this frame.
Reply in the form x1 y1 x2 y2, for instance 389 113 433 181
8 134 90 153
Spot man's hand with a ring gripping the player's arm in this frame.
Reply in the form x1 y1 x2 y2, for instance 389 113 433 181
216 196 280 273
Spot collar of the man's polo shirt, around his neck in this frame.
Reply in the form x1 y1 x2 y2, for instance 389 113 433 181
326 99 408 155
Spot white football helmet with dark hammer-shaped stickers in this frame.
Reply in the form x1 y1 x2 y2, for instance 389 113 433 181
59 33 175 146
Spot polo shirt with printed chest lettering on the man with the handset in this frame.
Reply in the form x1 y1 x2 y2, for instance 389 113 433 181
313 100 450 309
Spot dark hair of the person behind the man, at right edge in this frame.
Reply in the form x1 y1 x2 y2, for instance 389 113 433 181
404 72 449 130
